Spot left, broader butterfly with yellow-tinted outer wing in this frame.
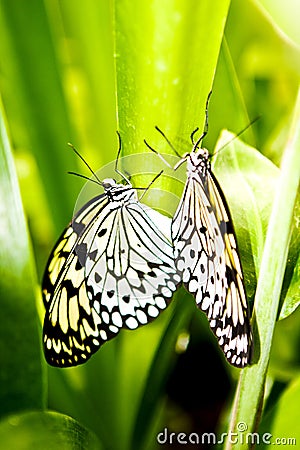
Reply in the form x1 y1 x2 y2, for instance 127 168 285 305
42 139 180 367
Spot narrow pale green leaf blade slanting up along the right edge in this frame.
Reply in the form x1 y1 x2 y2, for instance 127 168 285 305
226 90 300 449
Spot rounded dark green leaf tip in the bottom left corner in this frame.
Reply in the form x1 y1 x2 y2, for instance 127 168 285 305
0 411 104 450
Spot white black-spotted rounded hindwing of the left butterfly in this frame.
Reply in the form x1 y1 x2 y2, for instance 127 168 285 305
86 202 180 339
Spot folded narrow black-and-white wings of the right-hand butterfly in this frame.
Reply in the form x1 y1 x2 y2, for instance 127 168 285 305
172 171 252 367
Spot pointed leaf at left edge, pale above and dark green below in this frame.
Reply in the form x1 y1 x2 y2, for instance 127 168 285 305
0 105 45 415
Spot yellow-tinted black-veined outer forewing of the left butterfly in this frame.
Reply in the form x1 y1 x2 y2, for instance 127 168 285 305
42 195 108 367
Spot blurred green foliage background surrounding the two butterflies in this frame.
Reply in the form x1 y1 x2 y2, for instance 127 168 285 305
0 0 300 450
